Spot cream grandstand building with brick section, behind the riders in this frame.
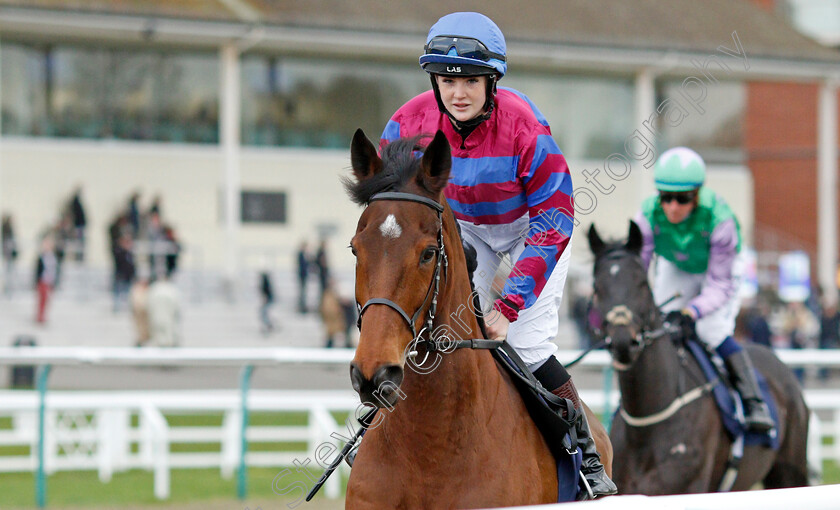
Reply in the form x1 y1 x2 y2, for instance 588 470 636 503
0 0 840 298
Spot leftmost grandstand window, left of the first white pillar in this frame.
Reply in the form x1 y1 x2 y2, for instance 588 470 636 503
0 42 219 143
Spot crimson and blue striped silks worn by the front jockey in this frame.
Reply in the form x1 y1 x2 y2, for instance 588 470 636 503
380 87 574 320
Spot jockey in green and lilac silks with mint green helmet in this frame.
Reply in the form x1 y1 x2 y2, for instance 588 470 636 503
635 147 773 432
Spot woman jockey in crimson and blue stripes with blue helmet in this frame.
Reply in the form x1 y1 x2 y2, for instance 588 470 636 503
381 12 616 496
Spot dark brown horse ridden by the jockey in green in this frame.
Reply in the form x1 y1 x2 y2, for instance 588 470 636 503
589 221 809 495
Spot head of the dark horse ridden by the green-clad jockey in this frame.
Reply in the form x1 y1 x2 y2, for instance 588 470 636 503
589 221 659 368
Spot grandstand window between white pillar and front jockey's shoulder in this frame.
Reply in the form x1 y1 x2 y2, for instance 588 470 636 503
242 55 430 148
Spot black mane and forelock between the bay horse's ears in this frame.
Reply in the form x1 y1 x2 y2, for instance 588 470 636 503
341 135 427 205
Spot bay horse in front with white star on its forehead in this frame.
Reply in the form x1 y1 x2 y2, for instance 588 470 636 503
344 130 610 510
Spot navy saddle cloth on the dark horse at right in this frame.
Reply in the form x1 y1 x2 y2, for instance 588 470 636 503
685 340 779 450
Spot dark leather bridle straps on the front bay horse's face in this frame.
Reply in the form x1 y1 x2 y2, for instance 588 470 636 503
356 191 449 352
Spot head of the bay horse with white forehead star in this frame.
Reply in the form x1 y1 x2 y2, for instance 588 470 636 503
345 130 452 407
